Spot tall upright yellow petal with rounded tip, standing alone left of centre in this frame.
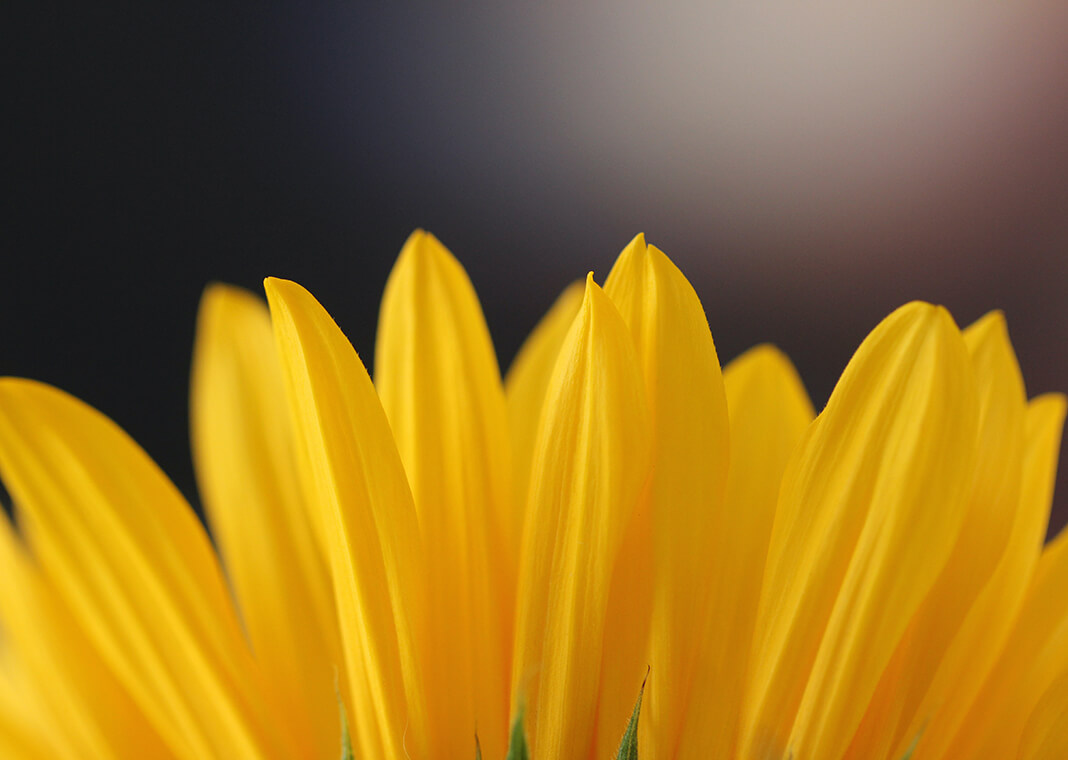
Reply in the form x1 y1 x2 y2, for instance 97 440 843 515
375 231 510 758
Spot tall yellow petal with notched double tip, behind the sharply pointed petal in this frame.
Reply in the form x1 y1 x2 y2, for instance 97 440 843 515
599 235 738 757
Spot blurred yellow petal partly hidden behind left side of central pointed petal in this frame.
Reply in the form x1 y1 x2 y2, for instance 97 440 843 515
504 283 583 514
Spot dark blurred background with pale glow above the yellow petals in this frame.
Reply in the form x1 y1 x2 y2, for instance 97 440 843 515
6 7 1068 528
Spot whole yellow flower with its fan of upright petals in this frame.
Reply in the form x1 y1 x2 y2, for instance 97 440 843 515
0 232 1068 760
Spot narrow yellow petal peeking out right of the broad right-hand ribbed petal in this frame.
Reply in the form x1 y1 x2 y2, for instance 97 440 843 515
850 312 1025 760
